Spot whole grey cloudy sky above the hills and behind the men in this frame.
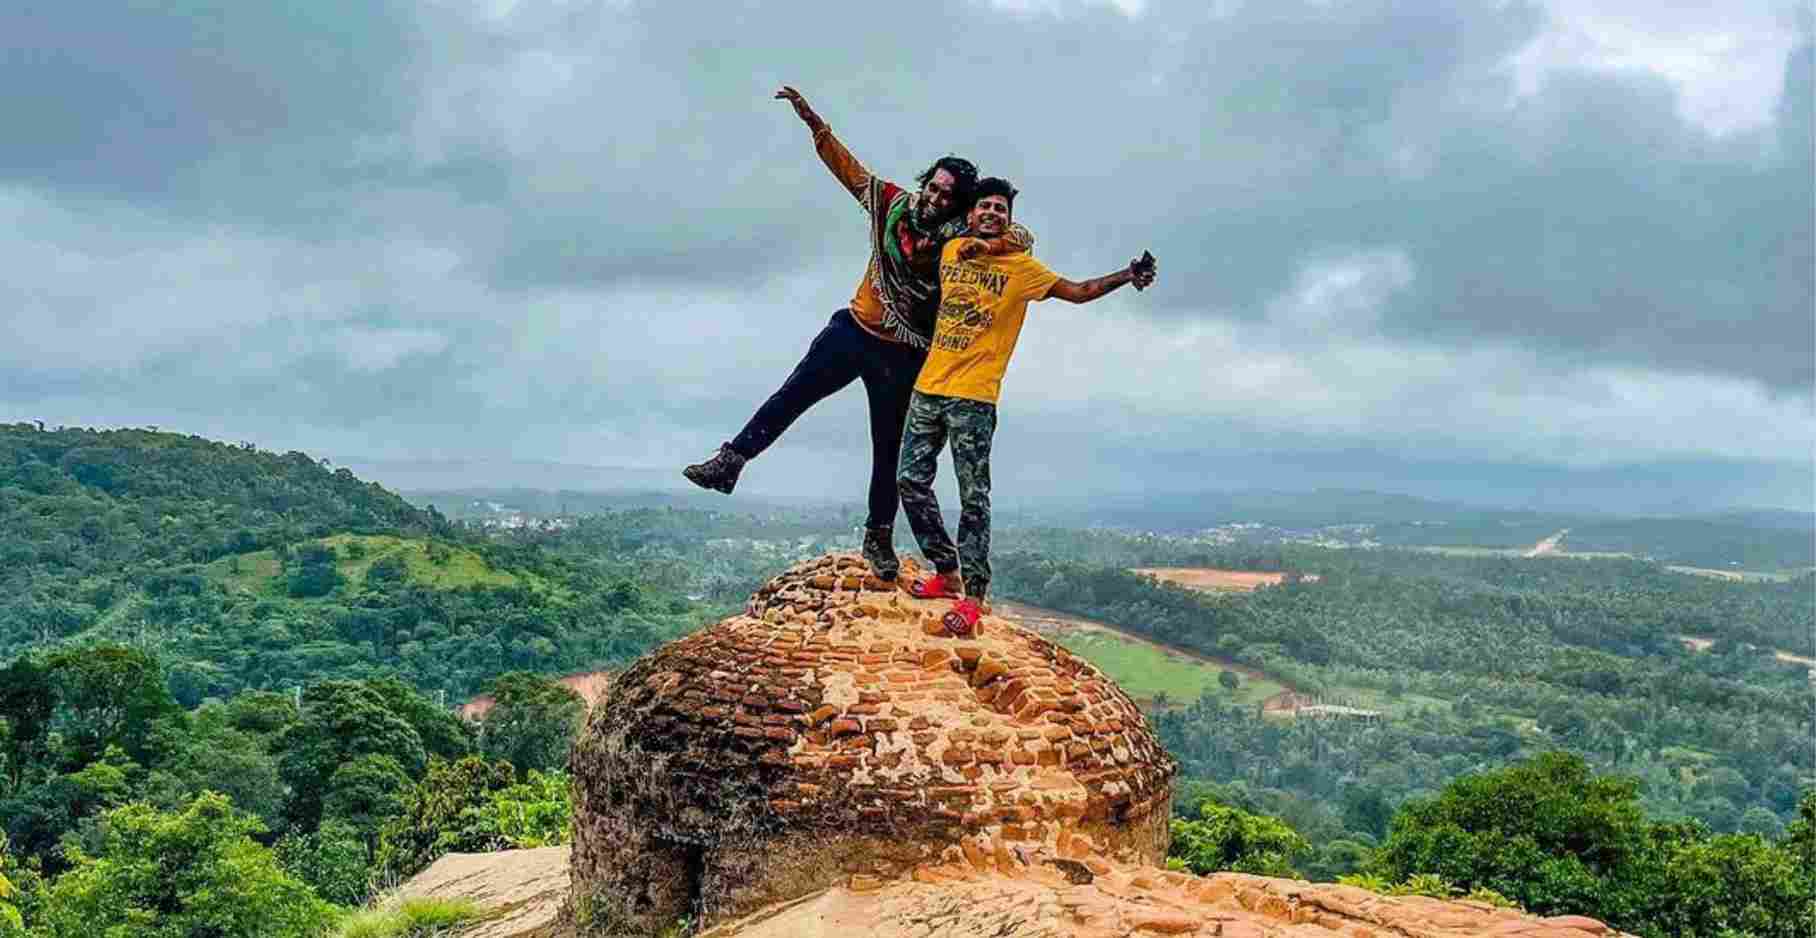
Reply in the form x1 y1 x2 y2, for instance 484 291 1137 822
0 0 1816 510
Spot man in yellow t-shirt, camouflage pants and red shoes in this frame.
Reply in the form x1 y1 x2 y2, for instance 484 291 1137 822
895 178 1155 635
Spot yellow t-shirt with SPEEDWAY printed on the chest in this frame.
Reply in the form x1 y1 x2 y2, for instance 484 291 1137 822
913 238 1059 403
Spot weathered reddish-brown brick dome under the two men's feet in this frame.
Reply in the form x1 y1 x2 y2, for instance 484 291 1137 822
572 555 1175 933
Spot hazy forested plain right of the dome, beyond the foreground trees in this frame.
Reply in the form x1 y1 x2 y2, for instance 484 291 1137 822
997 532 1816 831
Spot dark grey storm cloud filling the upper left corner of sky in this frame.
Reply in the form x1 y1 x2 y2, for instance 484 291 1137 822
0 0 416 210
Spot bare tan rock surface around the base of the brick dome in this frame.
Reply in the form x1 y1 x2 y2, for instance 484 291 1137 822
379 847 1618 938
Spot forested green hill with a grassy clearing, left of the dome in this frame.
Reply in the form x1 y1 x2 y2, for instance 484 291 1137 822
0 425 706 704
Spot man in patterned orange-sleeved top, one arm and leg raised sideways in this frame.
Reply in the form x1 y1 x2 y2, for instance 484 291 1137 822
683 87 1033 581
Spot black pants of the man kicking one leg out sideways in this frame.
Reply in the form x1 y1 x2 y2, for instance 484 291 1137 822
732 310 926 528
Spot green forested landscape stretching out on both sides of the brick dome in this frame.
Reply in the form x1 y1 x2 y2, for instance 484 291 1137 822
0 425 1816 938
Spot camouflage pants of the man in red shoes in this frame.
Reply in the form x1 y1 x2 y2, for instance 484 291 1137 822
895 392 997 599
